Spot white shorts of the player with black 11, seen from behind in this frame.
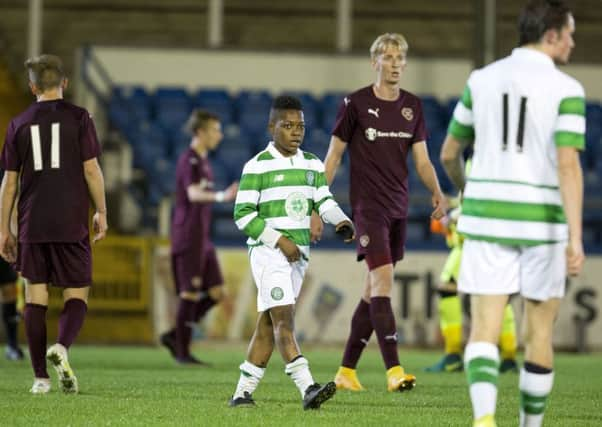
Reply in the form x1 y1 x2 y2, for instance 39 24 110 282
458 239 566 301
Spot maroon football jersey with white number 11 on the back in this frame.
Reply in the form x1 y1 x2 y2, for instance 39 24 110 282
0 99 100 243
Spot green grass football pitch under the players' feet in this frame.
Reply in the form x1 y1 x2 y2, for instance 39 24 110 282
0 342 602 427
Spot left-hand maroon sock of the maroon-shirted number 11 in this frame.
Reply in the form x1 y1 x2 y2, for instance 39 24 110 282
24 304 49 378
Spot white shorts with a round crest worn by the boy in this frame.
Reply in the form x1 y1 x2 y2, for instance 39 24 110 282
249 245 308 312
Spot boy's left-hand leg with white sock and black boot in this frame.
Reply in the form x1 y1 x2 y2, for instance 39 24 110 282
230 311 274 406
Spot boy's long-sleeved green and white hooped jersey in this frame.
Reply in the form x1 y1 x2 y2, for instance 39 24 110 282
234 143 338 257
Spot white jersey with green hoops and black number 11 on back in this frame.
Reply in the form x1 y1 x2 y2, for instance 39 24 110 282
448 48 585 245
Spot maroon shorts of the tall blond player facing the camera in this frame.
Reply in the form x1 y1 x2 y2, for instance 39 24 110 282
353 212 407 270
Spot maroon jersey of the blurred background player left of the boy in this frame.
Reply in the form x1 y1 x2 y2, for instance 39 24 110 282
171 148 213 254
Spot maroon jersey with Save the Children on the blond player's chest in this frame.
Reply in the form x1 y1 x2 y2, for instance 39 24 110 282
332 86 426 218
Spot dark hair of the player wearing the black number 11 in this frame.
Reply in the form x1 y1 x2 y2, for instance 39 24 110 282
518 0 571 46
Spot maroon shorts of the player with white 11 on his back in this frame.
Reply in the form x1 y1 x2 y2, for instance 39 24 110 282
16 236 92 288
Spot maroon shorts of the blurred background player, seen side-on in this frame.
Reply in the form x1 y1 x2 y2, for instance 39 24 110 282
171 248 224 294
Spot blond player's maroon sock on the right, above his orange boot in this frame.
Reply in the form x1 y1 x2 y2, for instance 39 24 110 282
370 297 399 369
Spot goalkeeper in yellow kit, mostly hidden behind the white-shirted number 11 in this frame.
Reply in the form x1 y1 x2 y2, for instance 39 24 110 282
425 203 518 373
